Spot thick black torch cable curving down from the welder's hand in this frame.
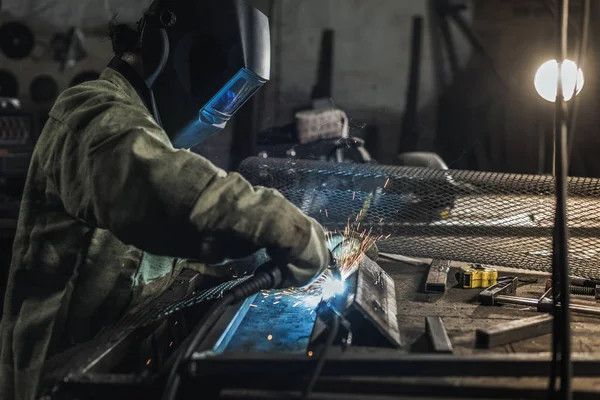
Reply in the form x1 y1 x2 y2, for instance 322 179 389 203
161 261 283 400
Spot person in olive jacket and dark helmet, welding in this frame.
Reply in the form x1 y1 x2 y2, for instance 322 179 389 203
0 0 329 400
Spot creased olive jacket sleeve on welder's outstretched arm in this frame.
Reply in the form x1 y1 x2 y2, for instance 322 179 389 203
54 99 314 263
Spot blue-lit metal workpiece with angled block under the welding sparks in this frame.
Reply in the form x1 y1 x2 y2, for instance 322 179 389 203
197 253 401 354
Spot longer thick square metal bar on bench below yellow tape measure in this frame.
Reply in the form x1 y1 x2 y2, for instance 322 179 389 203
475 315 552 349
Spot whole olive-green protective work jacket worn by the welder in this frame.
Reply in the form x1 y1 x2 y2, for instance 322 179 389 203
0 61 326 400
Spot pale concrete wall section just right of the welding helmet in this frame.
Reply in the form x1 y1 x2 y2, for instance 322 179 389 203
262 0 469 162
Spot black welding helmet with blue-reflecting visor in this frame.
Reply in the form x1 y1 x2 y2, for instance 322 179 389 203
140 0 271 148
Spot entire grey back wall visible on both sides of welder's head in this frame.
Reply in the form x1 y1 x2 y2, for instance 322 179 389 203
0 0 469 166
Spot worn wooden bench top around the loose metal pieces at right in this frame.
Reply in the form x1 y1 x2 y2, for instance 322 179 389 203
378 259 600 398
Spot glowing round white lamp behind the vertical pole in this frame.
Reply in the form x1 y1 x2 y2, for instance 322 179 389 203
533 60 584 102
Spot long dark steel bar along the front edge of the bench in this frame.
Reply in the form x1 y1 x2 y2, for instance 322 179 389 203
187 349 600 379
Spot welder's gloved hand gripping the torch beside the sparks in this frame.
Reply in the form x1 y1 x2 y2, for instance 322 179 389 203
267 218 331 287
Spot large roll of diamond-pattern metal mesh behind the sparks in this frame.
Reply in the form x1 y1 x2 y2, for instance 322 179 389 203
240 158 600 278
